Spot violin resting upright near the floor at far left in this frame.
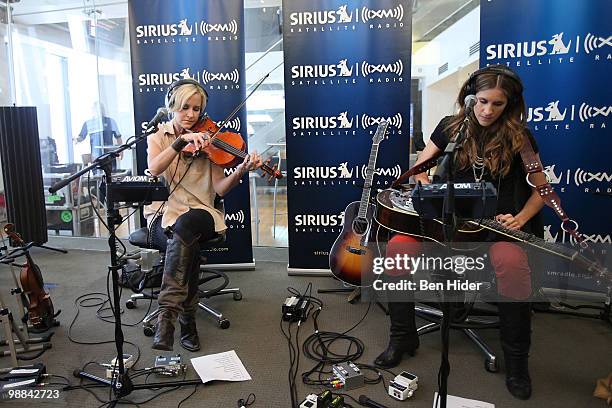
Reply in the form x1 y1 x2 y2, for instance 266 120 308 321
4 224 60 332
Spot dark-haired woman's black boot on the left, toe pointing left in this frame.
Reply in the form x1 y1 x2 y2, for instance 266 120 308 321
374 301 419 368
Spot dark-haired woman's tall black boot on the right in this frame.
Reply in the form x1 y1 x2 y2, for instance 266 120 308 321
498 302 531 400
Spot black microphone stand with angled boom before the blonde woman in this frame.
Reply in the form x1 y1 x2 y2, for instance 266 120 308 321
49 124 202 407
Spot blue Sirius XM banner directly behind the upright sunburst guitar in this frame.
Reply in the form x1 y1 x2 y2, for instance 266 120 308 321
283 0 412 272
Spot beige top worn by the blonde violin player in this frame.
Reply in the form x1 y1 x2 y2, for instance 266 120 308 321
144 122 227 232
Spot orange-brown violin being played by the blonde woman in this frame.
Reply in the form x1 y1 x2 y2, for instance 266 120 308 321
182 116 283 180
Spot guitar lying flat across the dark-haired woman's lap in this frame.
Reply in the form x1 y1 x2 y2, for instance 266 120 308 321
376 189 612 285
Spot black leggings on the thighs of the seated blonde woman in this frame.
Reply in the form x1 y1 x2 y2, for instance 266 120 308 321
150 208 215 251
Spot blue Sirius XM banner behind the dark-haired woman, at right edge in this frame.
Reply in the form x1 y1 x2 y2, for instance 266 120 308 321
480 0 612 294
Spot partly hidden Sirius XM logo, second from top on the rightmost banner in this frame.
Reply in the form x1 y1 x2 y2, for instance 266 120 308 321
527 100 612 131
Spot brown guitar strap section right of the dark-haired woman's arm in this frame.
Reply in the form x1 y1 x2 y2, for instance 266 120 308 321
520 135 588 248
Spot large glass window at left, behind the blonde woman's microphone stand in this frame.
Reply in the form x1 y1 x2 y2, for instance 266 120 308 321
10 2 134 237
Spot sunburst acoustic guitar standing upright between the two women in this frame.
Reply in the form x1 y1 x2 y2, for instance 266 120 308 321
329 121 389 286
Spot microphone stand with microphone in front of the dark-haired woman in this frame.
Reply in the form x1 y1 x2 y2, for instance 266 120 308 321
434 114 470 408
